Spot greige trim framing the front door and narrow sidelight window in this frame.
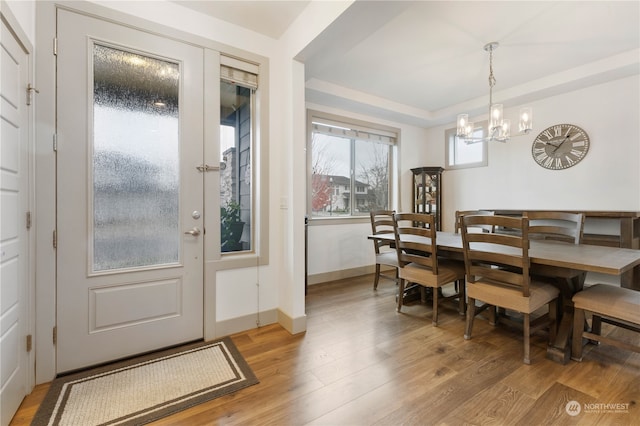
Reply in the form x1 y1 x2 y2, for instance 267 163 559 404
34 1 270 384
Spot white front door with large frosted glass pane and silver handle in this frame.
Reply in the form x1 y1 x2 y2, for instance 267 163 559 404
56 10 203 373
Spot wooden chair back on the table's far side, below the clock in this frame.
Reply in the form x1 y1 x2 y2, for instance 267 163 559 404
525 211 584 244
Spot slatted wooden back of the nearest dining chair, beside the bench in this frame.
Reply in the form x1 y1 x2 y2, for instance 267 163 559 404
461 215 530 297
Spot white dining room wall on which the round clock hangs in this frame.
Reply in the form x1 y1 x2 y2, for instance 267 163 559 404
436 76 640 230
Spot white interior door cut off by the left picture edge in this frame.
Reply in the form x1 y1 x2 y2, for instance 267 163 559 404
0 14 29 425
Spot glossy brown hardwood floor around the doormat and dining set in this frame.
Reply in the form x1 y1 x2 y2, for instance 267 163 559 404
11 275 640 426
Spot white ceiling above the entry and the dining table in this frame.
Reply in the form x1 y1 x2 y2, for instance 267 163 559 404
171 1 640 126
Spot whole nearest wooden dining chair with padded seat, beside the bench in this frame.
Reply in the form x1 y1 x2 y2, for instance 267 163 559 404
461 216 559 364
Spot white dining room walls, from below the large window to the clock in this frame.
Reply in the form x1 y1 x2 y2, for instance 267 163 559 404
309 75 640 275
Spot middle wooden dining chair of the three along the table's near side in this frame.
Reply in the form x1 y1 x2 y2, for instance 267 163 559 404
393 213 465 326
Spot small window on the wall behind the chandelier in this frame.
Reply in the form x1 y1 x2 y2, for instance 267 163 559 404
444 122 488 170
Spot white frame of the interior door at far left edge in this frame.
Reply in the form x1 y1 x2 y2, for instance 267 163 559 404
0 0 38 400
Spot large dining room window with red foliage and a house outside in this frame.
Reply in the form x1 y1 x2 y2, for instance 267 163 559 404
307 111 398 219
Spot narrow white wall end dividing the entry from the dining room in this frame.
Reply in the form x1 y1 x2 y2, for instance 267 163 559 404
270 0 352 326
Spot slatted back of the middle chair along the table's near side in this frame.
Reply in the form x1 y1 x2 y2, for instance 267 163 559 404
394 213 438 275
